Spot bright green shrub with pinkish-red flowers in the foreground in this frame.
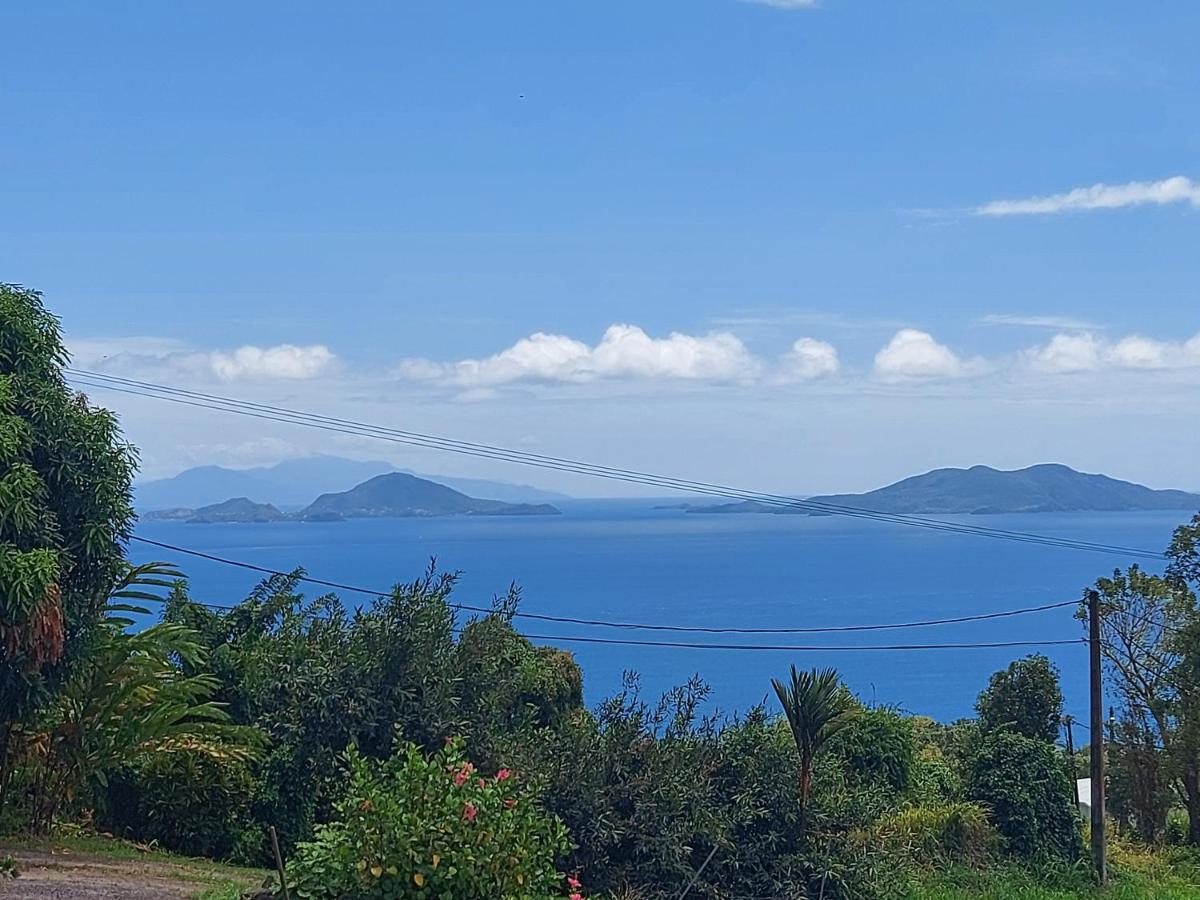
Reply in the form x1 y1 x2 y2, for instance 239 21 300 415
288 740 570 900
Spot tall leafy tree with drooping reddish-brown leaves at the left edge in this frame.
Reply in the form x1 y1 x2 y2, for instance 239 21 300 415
0 284 136 809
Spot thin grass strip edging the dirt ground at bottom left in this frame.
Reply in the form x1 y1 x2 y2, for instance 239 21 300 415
0 833 272 900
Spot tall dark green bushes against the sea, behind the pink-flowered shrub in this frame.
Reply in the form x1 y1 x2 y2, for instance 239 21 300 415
138 569 582 864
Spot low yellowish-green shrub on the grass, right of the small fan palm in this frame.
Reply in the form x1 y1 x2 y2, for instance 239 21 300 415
869 803 1000 865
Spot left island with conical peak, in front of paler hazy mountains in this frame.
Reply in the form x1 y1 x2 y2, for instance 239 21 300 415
143 472 559 524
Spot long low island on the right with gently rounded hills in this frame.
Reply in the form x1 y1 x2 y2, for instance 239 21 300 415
685 463 1200 516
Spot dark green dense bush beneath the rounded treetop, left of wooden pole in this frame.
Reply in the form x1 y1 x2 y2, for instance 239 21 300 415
968 732 1082 859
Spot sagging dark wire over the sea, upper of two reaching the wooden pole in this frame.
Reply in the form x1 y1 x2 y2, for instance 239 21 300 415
132 535 1079 646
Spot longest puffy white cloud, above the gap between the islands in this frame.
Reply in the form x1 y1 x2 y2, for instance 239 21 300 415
397 324 762 388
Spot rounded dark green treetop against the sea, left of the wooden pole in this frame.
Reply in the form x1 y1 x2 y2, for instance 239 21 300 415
976 654 1062 744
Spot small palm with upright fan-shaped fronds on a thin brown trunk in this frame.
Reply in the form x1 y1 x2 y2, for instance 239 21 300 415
770 666 856 812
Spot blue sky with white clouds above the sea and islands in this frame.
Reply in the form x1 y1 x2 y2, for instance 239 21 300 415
0 0 1200 492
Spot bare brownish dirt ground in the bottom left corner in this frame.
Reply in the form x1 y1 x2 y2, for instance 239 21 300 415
0 851 261 900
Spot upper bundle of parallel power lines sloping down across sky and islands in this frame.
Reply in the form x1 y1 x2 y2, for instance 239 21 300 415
67 370 1163 559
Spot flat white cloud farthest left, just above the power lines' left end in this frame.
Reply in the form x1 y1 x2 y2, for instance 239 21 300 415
68 337 337 382
